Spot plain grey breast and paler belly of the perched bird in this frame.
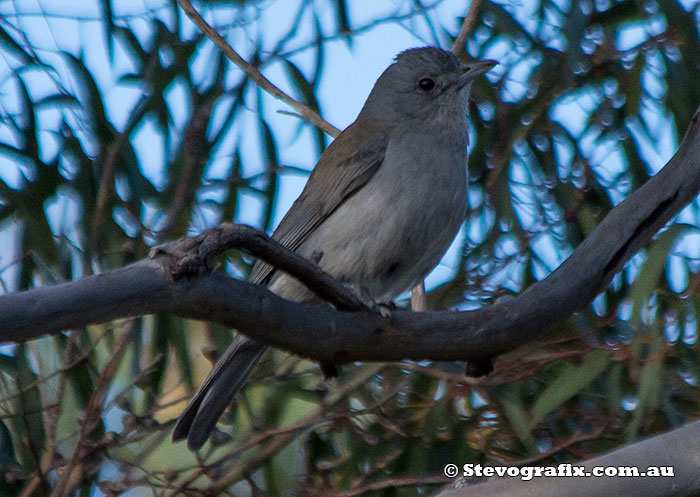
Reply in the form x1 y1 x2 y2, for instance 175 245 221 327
300 126 467 301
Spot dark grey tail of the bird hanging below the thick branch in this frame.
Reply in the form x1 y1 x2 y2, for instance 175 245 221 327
173 336 267 450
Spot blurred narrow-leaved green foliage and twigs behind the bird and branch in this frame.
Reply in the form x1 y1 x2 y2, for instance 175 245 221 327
0 0 700 495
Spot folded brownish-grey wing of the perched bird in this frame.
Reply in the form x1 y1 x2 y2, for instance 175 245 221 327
249 118 387 283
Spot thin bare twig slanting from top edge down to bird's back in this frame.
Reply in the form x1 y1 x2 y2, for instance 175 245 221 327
177 0 340 136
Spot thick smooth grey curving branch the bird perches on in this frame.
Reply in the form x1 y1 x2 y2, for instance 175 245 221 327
0 106 700 363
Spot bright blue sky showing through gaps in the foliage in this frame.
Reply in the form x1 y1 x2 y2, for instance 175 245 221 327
0 0 688 302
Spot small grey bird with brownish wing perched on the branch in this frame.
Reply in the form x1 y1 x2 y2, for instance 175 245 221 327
173 47 497 450
